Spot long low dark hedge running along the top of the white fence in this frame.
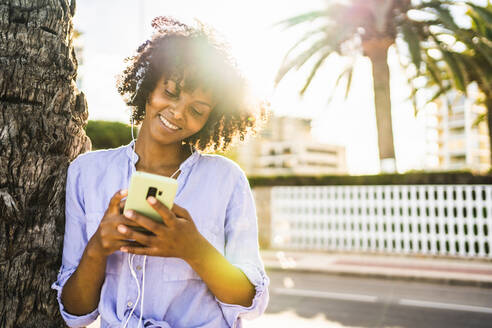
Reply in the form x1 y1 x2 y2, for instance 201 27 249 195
248 172 492 187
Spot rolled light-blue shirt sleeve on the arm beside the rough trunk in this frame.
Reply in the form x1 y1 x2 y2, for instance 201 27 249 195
51 161 99 327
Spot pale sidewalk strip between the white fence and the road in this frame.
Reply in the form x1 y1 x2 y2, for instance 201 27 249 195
261 250 492 288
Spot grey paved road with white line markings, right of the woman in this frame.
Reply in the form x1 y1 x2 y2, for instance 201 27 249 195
267 270 492 328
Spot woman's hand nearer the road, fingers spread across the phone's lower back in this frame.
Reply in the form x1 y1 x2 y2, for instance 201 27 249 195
117 197 205 261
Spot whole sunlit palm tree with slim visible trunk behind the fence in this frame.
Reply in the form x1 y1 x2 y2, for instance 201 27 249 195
276 0 478 171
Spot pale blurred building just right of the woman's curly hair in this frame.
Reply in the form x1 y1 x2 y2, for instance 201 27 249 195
237 116 347 175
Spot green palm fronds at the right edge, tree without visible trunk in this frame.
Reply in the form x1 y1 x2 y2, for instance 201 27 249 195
404 1 492 163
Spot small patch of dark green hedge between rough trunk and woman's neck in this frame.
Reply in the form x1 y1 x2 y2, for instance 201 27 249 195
85 121 138 150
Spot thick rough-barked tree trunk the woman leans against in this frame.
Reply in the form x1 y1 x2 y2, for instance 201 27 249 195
0 0 90 327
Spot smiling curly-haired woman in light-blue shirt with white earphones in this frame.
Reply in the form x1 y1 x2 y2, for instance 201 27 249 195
53 17 269 328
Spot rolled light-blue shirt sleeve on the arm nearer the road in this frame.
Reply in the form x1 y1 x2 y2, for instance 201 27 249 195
215 172 270 328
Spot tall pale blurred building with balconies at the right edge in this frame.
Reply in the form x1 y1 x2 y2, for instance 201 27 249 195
426 87 490 172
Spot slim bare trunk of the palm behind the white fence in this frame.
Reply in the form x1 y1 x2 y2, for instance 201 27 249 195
363 38 396 172
